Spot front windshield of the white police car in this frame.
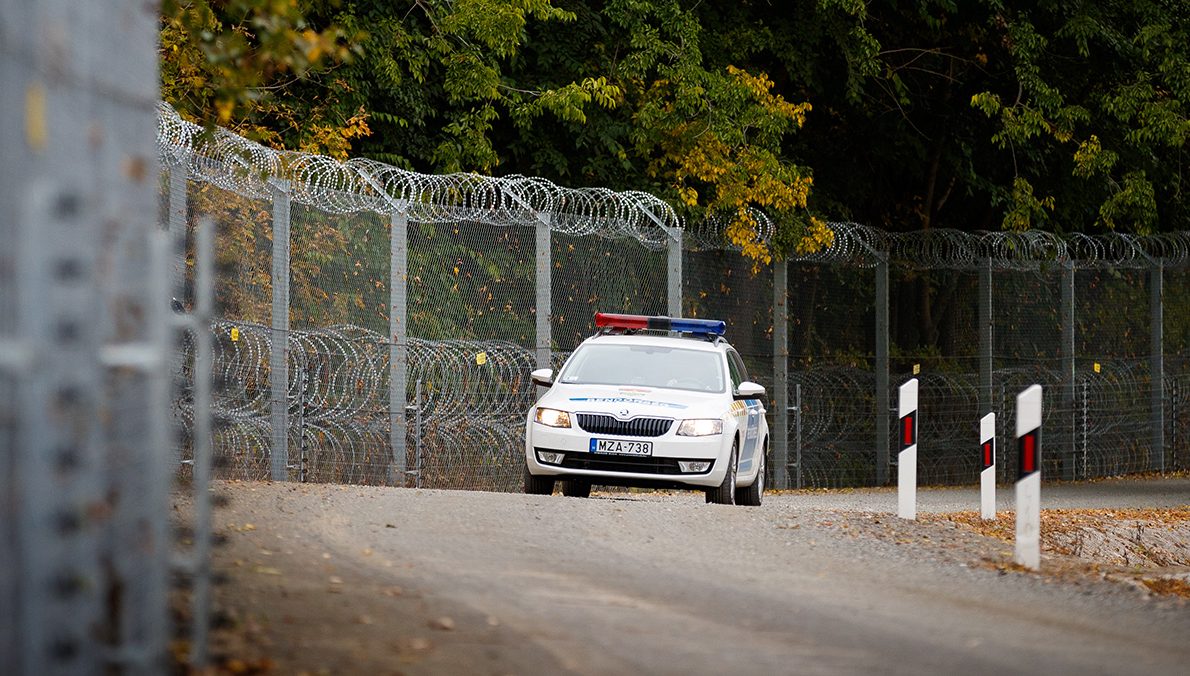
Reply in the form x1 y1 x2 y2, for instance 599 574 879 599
558 344 727 392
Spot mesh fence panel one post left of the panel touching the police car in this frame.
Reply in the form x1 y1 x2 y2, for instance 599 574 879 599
287 204 392 483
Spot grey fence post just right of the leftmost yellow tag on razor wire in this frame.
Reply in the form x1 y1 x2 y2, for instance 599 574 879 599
269 179 289 481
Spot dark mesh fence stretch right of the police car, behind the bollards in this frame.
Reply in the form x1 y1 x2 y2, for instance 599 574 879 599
776 229 1190 486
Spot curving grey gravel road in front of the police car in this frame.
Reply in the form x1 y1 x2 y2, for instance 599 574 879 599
204 480 1190 674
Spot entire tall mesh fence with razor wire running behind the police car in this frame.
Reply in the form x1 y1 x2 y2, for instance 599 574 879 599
158 106 1190 490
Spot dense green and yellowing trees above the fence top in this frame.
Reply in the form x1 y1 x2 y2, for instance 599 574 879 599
162 0 1190 251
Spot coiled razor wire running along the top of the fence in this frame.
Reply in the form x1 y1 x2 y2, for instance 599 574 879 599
157 102 1190 270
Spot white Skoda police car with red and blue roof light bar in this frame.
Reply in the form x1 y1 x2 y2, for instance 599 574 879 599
525 313 769 505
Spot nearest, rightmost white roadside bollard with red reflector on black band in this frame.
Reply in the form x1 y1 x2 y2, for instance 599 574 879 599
1015 384 1041 570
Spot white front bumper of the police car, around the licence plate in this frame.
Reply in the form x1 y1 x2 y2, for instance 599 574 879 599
525 421 731 488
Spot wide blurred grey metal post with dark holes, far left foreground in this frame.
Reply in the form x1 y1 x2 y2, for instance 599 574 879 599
13 178 108 674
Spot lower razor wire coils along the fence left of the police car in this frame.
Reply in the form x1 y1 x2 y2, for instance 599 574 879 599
176 320 536 489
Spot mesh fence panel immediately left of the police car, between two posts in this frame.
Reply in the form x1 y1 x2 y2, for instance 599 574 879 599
406 223 537 490
